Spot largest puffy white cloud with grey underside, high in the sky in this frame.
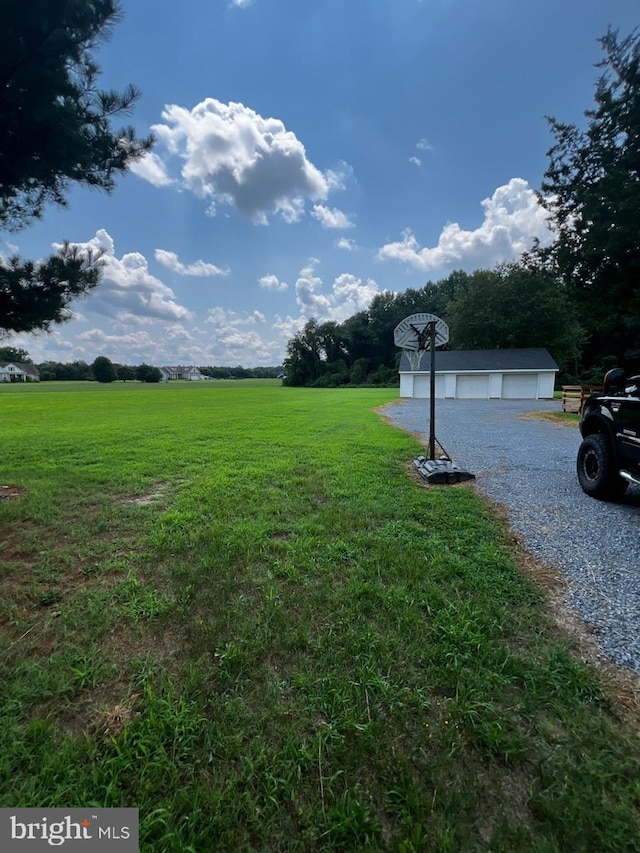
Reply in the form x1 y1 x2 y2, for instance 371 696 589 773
152 98 330 224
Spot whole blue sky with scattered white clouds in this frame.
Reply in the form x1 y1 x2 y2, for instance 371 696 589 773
6 0 639 366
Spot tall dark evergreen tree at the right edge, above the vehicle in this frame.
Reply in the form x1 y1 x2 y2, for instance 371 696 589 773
540 30 640 366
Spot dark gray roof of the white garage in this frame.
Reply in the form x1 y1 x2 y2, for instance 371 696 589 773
400 347 558 373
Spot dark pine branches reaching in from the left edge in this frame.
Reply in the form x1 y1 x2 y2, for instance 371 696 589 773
0 0 152 335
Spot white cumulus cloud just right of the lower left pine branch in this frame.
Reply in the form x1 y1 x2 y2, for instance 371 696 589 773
53 228 191 321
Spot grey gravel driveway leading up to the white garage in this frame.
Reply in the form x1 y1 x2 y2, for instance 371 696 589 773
384 400 640 673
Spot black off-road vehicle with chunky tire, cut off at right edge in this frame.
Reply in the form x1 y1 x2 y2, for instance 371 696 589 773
577 368 640 500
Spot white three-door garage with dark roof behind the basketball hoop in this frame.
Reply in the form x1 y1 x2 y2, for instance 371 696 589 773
400 348 558 400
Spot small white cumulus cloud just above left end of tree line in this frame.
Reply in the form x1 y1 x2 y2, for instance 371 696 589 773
296 259 379 323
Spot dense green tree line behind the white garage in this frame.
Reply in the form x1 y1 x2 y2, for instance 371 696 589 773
284 261 583 387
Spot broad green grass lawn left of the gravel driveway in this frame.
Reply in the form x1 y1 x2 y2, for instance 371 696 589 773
0 381 640 853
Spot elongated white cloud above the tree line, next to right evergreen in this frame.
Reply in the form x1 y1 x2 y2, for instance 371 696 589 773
378 178 551 271
